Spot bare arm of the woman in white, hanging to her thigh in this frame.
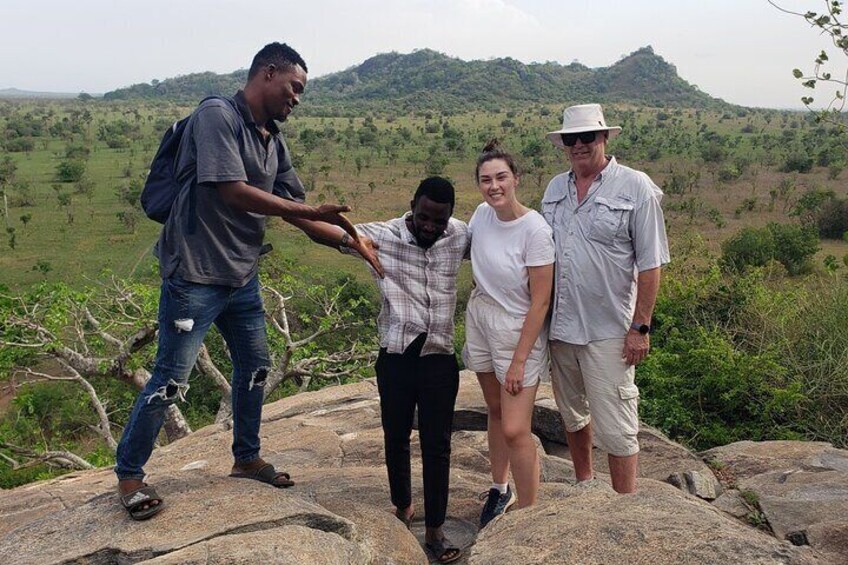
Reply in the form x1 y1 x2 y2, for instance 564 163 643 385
504 264 554 394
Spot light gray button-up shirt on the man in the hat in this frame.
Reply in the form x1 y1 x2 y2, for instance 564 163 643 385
542 157 669 345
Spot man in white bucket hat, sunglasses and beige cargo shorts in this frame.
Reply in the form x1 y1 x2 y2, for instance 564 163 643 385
542 104 669 493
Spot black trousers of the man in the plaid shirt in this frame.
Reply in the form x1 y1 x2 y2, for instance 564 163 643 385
376 334 459 528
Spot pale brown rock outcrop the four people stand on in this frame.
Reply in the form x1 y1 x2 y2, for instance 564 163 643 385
0 373 848 565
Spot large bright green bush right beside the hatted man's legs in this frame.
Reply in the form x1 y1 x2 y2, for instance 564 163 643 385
637 266 813 449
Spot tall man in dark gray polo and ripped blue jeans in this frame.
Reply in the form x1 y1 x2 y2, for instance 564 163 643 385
115 43 376 520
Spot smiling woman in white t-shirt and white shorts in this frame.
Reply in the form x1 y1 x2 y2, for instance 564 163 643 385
463 140 554 527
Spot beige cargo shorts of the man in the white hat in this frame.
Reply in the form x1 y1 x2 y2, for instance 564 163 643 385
551 338 639 457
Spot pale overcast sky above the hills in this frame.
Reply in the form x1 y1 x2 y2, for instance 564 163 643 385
0 0 848 108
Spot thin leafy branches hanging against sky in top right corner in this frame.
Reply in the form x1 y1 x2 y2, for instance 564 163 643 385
769 0 848 131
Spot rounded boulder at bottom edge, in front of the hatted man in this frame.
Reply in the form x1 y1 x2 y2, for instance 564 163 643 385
468 479 814 565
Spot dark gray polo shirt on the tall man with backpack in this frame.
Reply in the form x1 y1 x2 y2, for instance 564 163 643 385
157 91 303 287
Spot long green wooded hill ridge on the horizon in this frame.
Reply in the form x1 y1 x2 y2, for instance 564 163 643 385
104 47 726 113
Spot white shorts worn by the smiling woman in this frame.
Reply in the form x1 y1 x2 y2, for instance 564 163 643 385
462 290 550 387
